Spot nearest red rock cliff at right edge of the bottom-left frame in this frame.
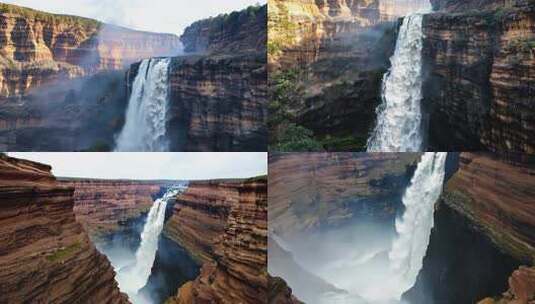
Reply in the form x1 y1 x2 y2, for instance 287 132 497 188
171 178 267 304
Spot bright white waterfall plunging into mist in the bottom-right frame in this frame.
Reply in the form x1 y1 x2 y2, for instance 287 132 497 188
388 152 447 299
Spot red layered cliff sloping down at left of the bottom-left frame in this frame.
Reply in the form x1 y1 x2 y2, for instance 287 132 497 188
0 156 129 304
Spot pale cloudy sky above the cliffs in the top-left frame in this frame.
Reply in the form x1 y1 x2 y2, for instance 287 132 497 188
2 0 266 35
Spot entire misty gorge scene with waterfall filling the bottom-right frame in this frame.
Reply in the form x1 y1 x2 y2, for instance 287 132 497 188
268 153 535 304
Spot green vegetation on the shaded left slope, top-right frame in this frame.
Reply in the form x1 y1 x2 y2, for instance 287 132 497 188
268 70 323 152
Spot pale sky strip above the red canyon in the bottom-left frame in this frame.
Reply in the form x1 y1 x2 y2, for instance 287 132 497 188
8 152 267 180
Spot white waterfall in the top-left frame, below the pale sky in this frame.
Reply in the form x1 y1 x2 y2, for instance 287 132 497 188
116 58 171 152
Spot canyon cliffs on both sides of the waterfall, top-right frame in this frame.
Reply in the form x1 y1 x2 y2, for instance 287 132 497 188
268 0 535 153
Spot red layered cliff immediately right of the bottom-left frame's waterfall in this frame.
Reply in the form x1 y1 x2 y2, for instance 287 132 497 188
164 180 241 262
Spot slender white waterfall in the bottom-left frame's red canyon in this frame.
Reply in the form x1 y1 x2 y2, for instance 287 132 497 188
117 188 180 303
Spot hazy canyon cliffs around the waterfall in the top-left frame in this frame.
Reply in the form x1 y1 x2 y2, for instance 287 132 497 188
0 4 267 151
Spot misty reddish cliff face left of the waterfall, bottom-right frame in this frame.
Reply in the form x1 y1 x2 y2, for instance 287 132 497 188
268 153 420 236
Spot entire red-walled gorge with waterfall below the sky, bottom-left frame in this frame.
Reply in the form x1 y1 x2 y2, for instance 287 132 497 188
0 155 267 304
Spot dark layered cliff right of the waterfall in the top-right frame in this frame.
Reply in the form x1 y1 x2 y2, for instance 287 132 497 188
423 0 535 153
